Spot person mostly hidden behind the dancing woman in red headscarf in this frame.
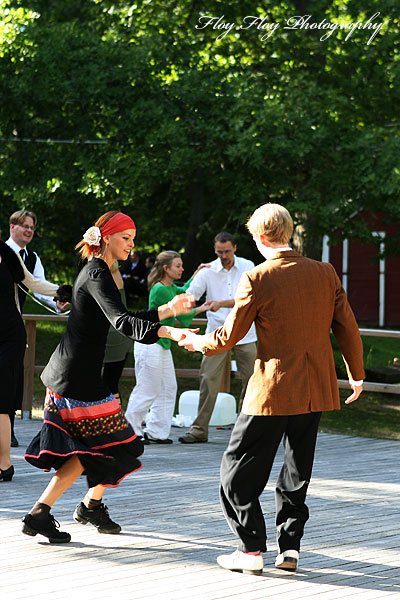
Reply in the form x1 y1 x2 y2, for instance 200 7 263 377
103 261 132 404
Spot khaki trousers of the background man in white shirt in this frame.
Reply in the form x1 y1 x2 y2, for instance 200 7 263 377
189 342 257 440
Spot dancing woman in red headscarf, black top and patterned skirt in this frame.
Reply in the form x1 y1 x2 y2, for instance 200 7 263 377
22 211 194 543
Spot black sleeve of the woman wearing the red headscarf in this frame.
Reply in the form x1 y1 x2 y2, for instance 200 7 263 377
87 270 161 344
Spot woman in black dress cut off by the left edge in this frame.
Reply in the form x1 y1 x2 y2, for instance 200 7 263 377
0 241 58 481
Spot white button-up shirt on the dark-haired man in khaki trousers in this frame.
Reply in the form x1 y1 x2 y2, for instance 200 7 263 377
186 256 257 345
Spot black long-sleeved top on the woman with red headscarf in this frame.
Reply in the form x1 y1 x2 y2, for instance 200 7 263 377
41 258 161 402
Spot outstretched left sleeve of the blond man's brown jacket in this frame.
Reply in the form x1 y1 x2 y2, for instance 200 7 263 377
202 272 257 356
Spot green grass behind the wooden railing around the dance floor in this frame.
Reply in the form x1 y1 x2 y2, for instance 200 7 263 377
24 298 400 440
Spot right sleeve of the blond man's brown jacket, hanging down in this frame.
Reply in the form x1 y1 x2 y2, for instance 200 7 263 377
332 267 365 381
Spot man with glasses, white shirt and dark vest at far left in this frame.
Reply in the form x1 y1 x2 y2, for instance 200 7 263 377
6 210 58 448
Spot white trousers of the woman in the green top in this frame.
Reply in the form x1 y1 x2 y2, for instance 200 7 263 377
125 342 177 440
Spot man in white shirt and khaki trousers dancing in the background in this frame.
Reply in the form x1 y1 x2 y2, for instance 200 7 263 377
179 232 257 444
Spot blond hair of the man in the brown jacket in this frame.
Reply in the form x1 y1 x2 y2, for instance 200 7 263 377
246 203 293 244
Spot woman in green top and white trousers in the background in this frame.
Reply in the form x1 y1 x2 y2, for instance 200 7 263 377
125 250 209 444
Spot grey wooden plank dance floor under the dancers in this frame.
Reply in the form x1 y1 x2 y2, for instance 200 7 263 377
0 420 400 600
